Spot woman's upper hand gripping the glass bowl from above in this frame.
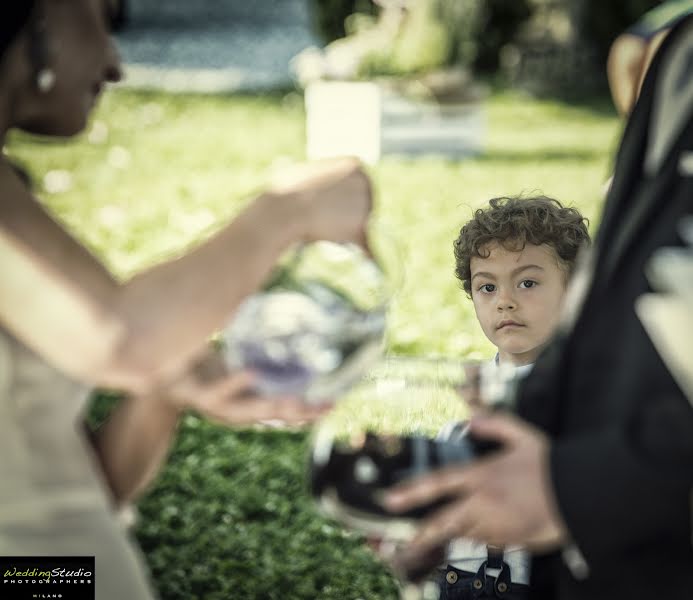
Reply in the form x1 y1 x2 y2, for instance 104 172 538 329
269 158 373 250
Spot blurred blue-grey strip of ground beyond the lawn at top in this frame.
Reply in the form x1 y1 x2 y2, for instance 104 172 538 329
116 0 320 92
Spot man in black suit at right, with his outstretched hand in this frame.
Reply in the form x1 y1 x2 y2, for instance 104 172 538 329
385 17 693 600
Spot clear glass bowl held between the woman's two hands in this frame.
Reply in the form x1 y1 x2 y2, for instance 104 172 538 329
222 238 399 403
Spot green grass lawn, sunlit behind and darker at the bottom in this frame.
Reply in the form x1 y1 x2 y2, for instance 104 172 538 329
8 86 619 600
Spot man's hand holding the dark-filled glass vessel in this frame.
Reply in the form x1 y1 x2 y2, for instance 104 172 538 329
384 415 568 562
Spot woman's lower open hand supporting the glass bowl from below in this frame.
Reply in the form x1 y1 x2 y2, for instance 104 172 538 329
161 352 329 426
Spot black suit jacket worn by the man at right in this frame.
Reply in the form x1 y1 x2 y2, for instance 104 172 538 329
518 17 693 600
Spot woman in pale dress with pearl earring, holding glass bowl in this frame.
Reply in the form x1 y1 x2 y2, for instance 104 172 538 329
0 0 371 600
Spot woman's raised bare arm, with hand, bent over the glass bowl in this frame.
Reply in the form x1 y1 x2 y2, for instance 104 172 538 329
0 161 371 393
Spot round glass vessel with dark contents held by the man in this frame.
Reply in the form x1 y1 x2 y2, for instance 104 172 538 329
310 359 518 540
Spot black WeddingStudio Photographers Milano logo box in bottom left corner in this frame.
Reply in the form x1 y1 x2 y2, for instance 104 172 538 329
0 556 95 600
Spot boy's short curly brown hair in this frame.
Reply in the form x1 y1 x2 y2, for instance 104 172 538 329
453 196 590 296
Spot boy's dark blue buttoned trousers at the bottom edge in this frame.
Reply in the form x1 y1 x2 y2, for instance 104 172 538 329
437 562 529 600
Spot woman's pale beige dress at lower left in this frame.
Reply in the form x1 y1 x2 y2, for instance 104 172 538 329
0 328 154 600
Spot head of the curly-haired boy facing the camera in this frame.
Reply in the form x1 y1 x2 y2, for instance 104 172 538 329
454 196 589 366
